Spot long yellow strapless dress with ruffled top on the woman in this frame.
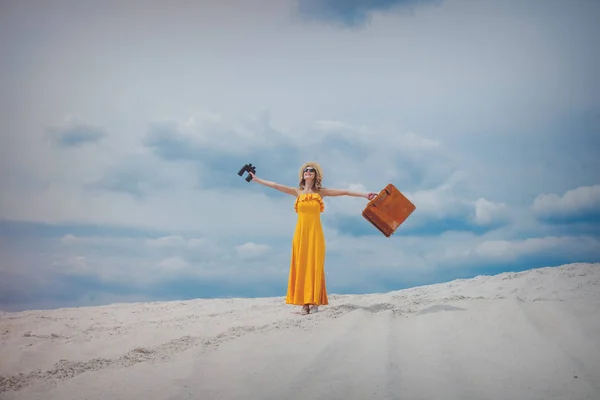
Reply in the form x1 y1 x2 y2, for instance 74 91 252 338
285 193 329 305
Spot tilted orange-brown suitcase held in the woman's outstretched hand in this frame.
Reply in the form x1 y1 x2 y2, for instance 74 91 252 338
362 183 416 237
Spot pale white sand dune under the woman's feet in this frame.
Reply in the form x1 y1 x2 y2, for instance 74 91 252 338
0 264 600 400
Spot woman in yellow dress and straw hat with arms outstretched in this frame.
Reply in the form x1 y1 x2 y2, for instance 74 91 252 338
250 162 377 314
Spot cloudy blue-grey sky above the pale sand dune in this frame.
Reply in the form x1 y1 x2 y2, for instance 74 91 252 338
0 0 600 311
